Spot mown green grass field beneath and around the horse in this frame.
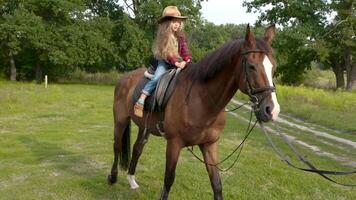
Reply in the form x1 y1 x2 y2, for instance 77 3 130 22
0 82 356 200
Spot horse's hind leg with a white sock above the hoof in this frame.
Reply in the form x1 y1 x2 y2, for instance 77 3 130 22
127 128 149 189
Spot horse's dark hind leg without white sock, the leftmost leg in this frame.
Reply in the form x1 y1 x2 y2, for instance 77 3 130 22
108 118 130 184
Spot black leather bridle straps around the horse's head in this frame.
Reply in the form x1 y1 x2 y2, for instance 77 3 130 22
242 49 276 104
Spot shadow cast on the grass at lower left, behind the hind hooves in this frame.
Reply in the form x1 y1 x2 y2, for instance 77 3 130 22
19 136 144 199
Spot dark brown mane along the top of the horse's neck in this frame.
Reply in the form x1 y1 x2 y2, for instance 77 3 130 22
187 38 271 82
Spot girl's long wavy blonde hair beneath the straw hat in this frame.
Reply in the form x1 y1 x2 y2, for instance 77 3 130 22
152 20 183 60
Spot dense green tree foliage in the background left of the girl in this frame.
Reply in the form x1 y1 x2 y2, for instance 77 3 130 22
0 0 211 80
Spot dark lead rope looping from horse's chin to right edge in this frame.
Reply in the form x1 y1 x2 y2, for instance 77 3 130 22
259 122 356 187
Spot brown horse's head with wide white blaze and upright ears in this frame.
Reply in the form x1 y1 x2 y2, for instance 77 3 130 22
240 25 280 122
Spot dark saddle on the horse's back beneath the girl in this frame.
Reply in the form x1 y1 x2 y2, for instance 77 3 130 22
132 62 180 112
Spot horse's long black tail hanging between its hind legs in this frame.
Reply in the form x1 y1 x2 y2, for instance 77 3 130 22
119 120 131 171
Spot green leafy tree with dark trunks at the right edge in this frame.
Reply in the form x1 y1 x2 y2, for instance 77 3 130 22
315 1 356 90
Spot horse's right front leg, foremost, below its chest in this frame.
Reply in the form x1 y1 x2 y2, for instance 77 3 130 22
199 142 223 200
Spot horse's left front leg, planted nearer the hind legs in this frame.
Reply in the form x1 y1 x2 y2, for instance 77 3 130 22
160 140 182 200
